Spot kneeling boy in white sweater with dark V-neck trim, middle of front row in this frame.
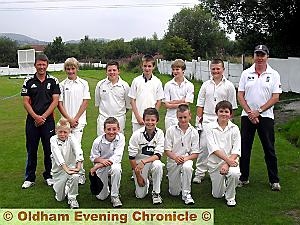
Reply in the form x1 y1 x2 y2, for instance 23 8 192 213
128 108 164 204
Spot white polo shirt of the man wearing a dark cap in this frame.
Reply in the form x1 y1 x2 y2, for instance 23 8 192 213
238 64 282 119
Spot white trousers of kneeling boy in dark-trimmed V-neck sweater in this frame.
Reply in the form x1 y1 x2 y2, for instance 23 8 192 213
133 160 164 198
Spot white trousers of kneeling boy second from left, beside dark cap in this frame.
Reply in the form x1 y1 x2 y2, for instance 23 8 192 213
96 163 122 200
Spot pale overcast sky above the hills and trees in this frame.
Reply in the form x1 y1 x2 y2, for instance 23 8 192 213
0 0 199 42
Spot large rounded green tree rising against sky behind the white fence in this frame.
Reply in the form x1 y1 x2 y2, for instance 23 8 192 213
165 5 229 58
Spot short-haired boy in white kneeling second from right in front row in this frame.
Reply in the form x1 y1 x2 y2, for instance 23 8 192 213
165 104 199 205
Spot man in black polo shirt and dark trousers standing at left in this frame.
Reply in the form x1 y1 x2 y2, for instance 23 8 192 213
21 54 60 189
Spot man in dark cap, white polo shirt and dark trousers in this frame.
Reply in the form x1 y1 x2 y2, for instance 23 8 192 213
238 45 282 191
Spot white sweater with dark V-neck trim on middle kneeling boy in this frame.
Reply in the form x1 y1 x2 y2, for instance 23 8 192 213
128 127 165 160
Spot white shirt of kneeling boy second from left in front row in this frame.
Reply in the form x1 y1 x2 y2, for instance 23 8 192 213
90 133 125 163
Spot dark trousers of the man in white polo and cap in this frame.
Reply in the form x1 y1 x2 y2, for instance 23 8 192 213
240 116 279 183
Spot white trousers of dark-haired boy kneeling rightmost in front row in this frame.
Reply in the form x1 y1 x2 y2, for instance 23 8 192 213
209 166 241 201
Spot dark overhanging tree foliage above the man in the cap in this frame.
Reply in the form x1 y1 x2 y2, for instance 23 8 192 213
201 0 300 57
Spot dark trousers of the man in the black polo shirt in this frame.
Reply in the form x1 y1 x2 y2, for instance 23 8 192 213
25 117 55 182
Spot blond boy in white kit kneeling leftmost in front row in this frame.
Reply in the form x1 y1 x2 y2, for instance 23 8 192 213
50 119 83 209
